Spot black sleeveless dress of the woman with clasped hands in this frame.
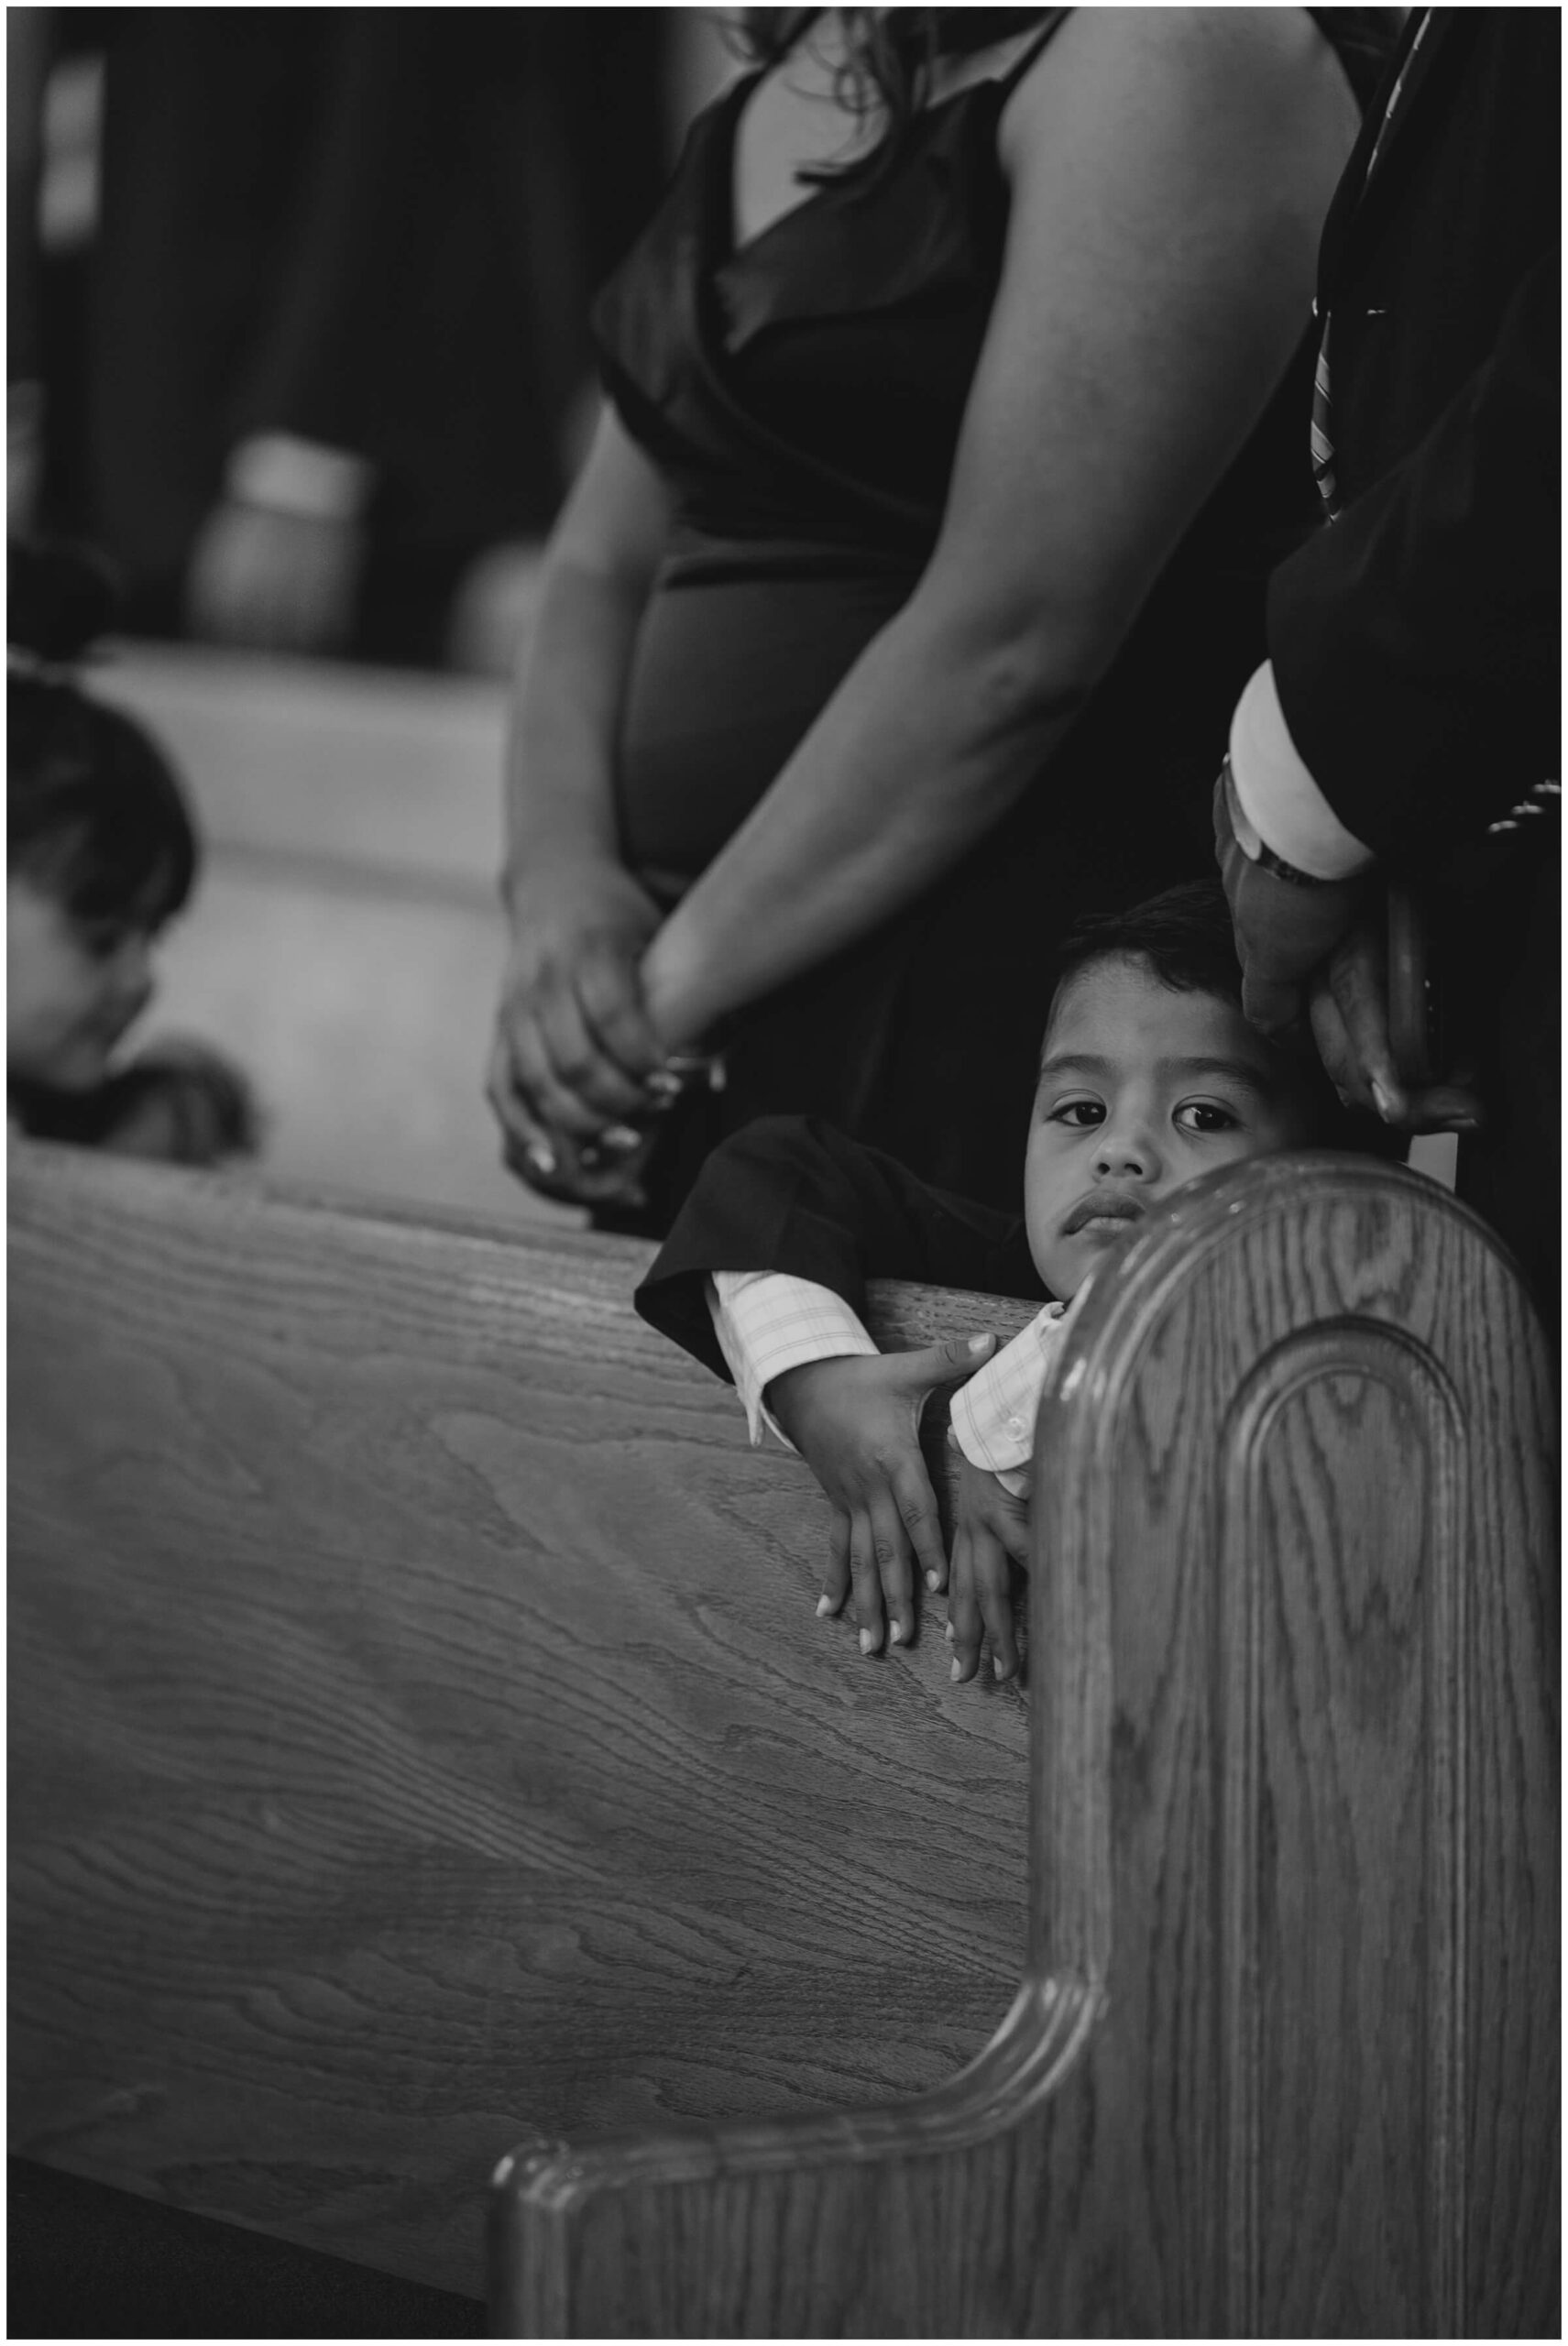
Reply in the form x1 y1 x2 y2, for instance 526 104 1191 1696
594 9 1387 1229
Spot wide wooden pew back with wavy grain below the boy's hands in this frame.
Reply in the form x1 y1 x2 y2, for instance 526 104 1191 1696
9 1145 1042 2292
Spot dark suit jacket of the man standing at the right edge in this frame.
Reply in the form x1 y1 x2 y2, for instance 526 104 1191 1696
1267 7 1561 866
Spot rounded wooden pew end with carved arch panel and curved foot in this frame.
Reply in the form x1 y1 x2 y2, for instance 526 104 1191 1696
493 1157 1559 2337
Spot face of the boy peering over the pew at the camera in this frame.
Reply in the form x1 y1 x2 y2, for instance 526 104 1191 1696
1024 955 1310 1299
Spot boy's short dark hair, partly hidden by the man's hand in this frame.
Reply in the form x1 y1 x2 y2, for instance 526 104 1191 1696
1051 872 1406 1157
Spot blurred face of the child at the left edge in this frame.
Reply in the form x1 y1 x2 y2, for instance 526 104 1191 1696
5 877 152 1091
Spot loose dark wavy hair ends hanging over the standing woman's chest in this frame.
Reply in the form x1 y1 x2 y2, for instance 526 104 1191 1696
735 7 1061 181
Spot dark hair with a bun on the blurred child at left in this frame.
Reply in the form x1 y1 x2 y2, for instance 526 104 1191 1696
5 542 200 929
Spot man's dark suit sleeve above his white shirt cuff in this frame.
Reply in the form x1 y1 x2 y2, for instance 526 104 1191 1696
1267 248 1561 863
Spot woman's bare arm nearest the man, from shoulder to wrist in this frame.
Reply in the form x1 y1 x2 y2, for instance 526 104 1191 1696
643 7 1356 1042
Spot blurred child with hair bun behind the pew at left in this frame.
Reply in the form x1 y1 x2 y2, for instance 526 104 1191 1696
5 544 256 1164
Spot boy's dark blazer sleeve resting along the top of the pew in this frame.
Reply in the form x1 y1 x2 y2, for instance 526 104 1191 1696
634 1117 1047 1379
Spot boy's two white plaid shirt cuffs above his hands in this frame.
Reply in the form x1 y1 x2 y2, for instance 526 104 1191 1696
707 1272 1070 1496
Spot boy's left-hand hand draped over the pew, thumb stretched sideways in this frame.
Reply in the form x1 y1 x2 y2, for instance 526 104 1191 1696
768 1335 995 1654
